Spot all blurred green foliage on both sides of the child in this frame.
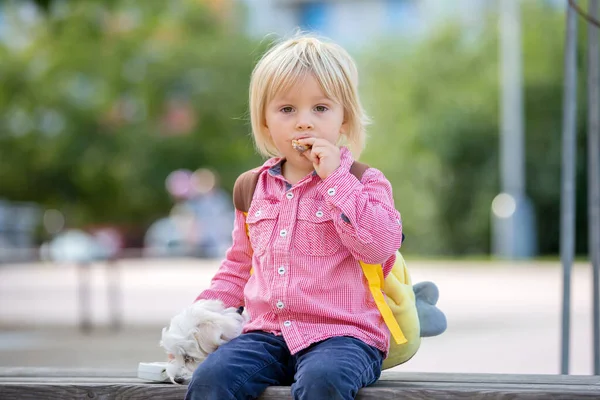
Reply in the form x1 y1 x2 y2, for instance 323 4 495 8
0 0 587 255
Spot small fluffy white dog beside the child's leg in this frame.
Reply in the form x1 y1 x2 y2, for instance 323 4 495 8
160 300 247 383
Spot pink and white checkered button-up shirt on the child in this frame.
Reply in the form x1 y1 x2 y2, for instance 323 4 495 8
198 147 402 354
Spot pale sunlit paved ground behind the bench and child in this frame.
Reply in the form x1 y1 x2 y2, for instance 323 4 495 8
0 259 592 375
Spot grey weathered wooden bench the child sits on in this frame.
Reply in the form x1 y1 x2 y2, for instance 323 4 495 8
0 368 600 400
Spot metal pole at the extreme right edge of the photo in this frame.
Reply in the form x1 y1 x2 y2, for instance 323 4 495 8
587 0 600 375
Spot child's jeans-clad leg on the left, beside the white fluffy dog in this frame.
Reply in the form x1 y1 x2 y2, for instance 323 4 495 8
185 332 290 400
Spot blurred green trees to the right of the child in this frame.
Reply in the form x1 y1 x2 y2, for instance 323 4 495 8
362 2 587 255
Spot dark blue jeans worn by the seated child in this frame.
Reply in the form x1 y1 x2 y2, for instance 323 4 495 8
185 332 383 400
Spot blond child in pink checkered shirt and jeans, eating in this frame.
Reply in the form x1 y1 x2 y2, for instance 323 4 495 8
186 36 402 400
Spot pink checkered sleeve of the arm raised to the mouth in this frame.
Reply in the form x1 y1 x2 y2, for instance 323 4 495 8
318 168 402 266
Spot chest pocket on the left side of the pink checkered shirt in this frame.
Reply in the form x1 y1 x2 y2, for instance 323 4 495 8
246 199 279 254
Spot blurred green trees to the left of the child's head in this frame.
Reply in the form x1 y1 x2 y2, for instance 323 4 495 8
0 0 261 234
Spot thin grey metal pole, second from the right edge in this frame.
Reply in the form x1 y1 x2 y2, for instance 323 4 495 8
560 4 577 374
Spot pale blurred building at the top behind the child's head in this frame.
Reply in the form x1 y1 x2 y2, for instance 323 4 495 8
242 0 496 46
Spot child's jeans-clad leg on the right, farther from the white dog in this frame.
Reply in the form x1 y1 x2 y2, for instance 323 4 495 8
292 336 383 400
